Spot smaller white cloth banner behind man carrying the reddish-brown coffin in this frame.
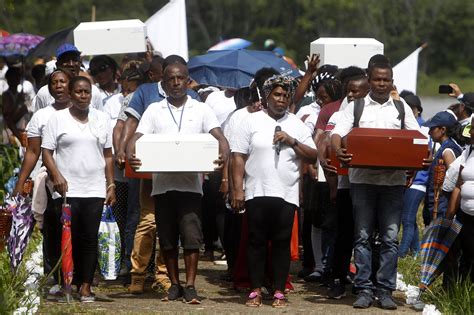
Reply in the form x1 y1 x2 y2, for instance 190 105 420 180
393 47 423 94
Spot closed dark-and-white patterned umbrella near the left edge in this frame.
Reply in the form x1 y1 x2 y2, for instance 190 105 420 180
7 194 34 271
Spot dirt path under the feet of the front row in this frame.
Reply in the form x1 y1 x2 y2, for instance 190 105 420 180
40 261 414 314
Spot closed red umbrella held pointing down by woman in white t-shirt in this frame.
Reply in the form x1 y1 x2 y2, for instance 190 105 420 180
61 195 74 303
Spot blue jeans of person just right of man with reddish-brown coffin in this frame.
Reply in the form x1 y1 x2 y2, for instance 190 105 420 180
398 188 425 257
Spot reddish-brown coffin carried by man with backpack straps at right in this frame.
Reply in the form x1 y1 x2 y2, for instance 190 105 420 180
345 128 429 170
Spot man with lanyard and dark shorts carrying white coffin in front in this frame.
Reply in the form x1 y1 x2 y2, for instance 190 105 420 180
127 64 229 304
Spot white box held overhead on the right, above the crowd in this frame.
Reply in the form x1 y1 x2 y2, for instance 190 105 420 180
309 37 383 69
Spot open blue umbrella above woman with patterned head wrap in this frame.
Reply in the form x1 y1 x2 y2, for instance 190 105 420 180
188 49 301 88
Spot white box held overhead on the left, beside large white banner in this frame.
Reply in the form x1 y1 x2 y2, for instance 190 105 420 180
74 19 146 55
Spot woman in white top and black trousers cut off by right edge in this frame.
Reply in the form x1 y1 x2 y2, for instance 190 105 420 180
446 115 474 282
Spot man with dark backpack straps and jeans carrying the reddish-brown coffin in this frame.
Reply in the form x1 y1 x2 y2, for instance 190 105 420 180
331 63 419 309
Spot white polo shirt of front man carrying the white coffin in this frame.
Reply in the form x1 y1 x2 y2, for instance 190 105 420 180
137 96 220 196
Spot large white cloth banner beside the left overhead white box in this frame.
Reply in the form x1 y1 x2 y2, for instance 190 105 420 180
145 0 188 60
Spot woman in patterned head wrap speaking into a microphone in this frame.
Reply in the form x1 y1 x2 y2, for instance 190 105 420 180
231 75 317 307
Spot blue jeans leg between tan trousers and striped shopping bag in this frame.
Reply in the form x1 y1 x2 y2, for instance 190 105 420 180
124 178 140 270
